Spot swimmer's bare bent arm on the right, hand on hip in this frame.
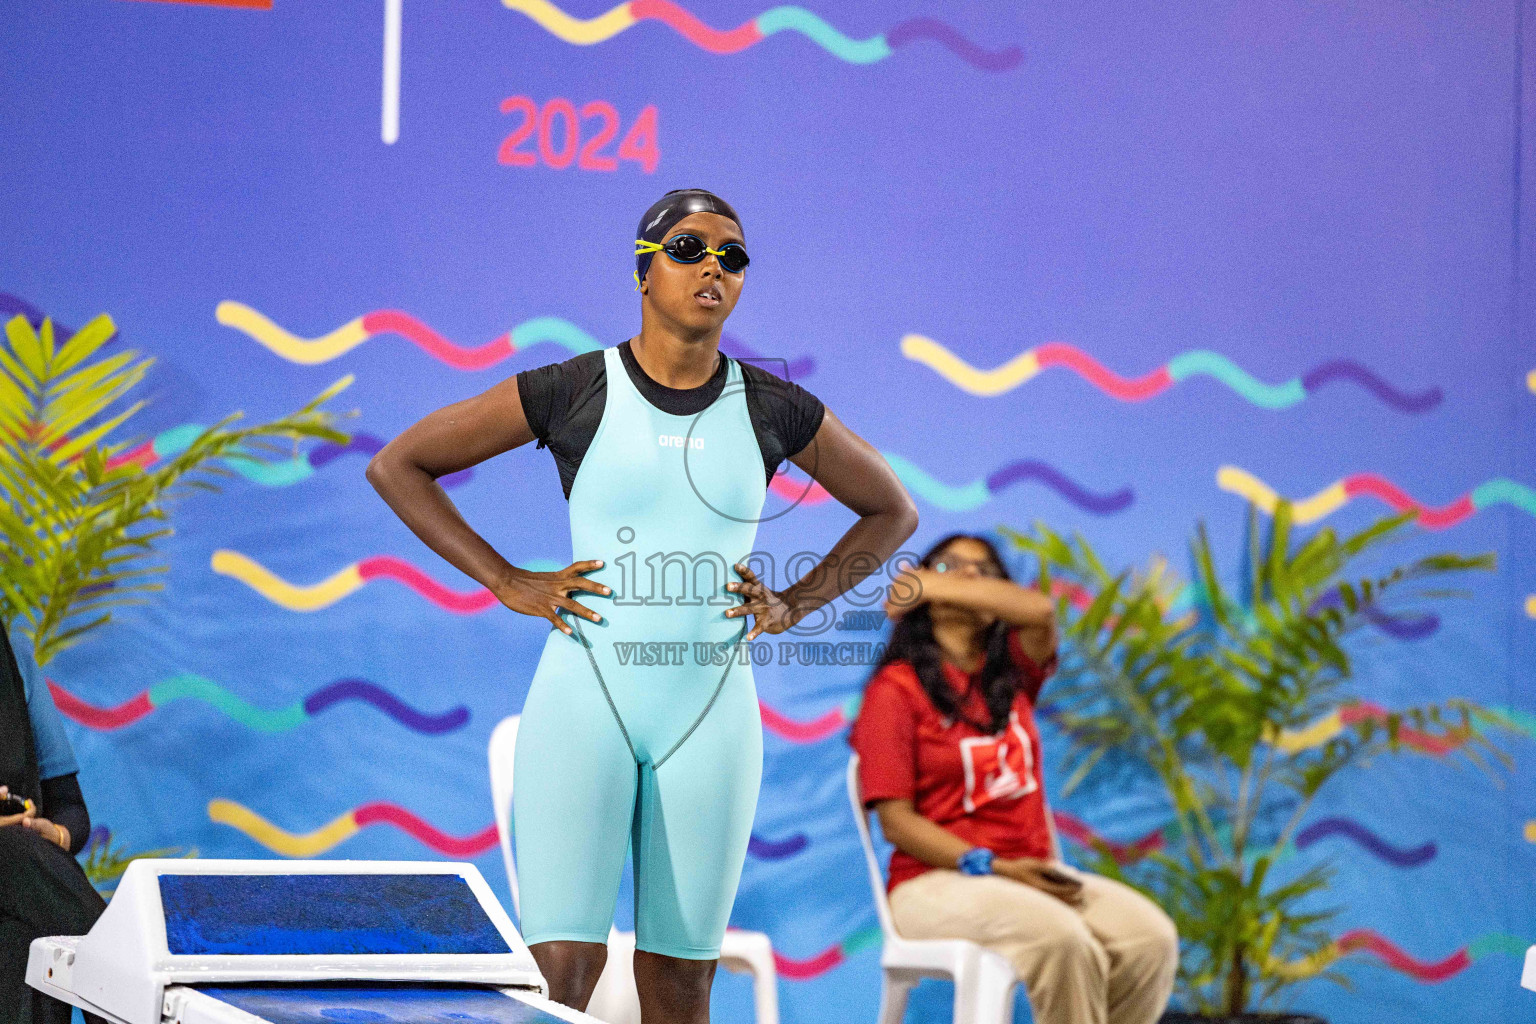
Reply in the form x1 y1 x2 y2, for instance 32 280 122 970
727 408 917 640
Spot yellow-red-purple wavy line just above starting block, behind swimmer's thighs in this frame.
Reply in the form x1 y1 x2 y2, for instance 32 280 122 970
207 798 809 860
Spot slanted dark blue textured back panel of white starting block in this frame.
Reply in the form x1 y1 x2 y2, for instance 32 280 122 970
160 875 511 955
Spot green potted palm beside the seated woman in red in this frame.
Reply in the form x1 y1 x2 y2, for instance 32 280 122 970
1003 504 1507 1022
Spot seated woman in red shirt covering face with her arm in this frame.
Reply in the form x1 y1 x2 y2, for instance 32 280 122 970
849 534 1178 1024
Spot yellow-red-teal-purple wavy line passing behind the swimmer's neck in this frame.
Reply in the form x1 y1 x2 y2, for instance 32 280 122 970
219 299 816 380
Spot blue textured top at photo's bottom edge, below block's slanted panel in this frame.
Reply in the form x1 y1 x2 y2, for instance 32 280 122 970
198 983 564 1024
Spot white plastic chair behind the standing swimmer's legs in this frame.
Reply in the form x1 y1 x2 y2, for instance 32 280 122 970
488 715 779 1024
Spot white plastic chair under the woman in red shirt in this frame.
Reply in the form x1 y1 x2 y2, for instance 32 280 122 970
848 754 1018 1024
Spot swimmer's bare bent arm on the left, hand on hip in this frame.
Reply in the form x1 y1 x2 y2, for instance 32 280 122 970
367 376 608 636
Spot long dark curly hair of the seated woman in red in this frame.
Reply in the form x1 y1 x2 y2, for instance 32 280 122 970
866 533 1020 734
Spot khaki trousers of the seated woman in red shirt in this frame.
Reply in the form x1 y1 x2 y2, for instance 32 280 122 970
891 869 1178 1024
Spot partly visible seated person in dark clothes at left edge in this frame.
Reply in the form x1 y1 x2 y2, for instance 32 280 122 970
0 628 106 1024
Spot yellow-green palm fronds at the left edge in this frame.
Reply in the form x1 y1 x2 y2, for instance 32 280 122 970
0 313 352 665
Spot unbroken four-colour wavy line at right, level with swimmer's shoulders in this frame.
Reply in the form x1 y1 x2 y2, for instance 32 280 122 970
902 335 1444 413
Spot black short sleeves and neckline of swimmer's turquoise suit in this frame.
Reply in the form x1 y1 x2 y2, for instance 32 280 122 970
518 341 825 500
